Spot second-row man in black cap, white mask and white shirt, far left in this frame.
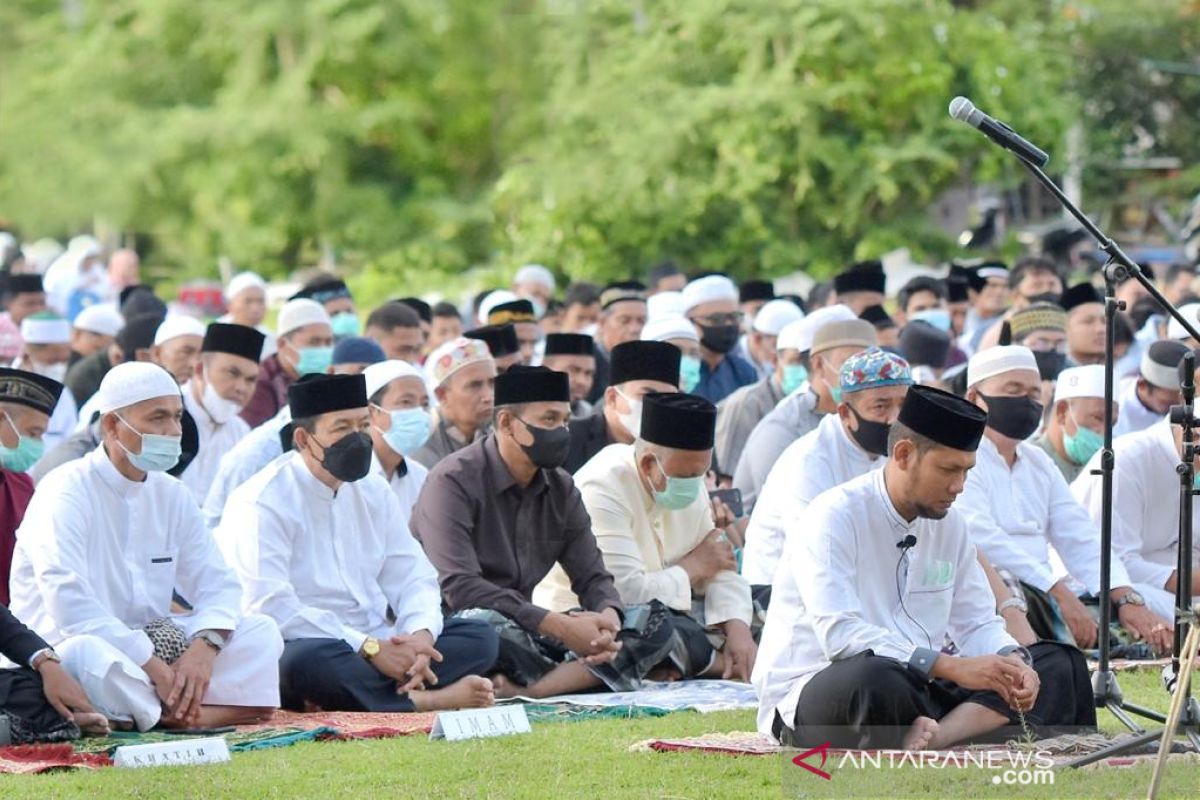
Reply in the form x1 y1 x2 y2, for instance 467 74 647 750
180 323 265 505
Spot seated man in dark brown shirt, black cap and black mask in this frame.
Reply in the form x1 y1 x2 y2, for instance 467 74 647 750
409 367 672 698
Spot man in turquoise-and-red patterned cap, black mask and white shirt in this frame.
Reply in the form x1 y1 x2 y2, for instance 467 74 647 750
742 347 912 585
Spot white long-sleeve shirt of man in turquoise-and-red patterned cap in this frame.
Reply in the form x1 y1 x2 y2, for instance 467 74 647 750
742 414 884 585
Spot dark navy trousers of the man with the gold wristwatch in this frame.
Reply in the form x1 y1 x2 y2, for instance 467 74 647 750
280 619 498 711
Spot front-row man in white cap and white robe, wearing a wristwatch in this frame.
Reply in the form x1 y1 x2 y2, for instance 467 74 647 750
12 362 283 730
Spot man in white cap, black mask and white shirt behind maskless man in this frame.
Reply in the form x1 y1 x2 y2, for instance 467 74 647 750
958 344 1170 649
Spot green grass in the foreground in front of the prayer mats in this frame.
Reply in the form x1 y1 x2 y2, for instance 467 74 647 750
0 673 1200 800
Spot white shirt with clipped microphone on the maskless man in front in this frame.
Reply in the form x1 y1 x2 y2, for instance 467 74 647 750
751 470 1016 735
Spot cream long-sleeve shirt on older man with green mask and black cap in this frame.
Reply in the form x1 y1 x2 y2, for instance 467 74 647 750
534 444 754 625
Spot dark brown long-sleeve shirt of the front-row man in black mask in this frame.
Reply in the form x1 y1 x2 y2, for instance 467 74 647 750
409 435 624 631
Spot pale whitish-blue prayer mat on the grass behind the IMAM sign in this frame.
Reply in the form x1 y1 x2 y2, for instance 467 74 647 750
504 680 758 714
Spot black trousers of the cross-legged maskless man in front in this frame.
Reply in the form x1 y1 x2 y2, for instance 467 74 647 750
775 642 1096 750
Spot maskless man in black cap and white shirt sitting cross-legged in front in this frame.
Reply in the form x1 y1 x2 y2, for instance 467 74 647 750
754 386 1096 750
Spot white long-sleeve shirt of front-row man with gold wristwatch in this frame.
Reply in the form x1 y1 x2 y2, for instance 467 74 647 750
214 452 442 650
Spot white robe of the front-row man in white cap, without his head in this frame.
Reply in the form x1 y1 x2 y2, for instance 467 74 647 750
11 446 283 730
